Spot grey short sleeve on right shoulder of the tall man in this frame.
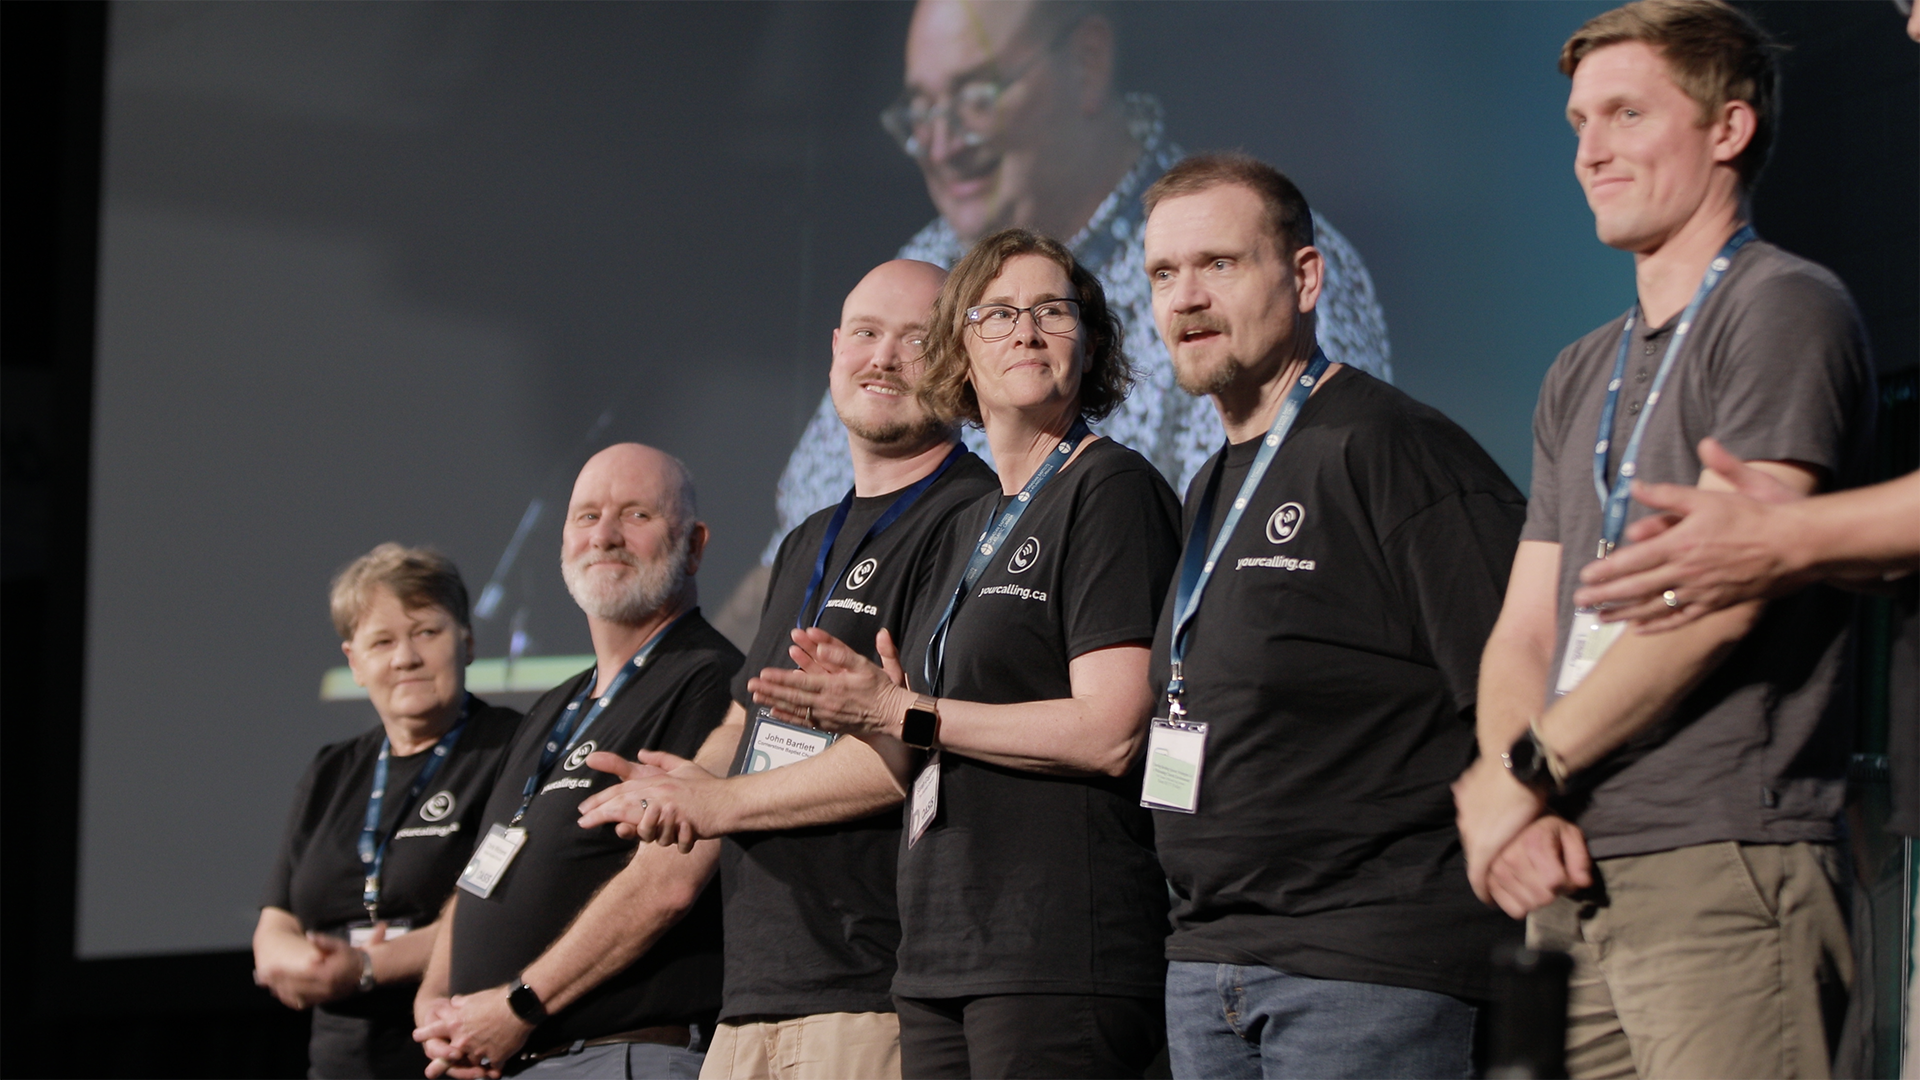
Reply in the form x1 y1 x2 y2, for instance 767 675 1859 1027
1709 271 1872 477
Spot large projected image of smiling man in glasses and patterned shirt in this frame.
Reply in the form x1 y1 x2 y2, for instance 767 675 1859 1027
766 0 1392 559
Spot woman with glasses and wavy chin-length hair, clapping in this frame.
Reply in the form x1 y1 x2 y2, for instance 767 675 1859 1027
751 229 1179 1080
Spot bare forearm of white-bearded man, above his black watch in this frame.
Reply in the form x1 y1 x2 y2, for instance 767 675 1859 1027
520 840 720 1013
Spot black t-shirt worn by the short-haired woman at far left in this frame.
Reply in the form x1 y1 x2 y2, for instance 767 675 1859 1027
259 698 520 1080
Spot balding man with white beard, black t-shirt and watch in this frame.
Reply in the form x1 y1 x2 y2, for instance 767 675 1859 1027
415 444 741 1080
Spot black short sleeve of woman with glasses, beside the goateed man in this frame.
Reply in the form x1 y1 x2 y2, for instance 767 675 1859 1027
1062 469 1181 659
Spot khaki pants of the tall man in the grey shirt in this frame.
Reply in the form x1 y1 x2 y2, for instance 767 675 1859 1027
1526 842 1853 1080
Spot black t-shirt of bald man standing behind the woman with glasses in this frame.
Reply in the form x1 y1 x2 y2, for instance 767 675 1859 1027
720 454 1000 1019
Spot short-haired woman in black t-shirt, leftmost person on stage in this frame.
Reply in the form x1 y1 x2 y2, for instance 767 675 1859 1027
253 544 520 1080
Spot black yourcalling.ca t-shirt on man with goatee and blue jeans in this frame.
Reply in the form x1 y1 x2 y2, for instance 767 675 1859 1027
1154 367 1526 999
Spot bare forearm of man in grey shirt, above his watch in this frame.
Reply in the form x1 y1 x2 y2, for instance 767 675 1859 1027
1540 600 1763 773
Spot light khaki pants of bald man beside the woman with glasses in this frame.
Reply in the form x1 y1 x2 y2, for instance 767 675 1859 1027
701 1013 900 1080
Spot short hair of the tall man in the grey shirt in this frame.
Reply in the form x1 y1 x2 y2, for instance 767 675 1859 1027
1559 0 1782 188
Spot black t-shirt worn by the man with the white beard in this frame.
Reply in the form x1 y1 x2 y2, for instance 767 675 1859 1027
449 609 741 1051
